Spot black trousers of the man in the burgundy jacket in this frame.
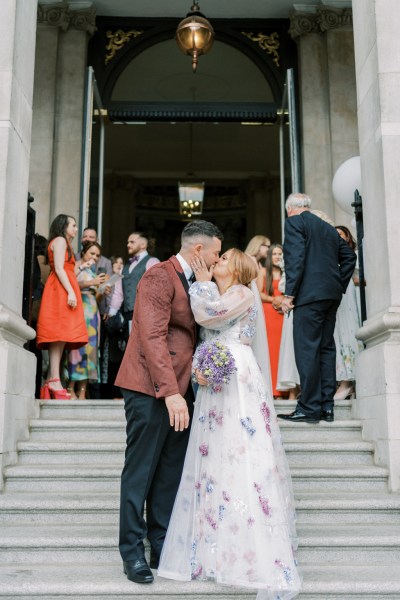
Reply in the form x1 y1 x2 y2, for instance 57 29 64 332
119 386 193 561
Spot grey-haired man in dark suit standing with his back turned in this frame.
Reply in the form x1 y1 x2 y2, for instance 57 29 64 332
278 194 356 423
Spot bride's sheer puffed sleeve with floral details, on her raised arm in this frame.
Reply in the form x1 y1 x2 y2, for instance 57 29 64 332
189 281 254 330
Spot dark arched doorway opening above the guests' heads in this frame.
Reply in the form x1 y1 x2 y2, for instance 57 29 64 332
90 20 295 258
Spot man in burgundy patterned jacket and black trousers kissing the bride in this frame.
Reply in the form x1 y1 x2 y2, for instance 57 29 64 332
115 221 223 583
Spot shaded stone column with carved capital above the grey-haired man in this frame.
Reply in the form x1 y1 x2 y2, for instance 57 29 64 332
290 6 358 224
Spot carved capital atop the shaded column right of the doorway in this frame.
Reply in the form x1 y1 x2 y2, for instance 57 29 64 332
289 6 353 39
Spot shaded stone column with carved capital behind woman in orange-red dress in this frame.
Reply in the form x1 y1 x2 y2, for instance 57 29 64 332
30 0 95 235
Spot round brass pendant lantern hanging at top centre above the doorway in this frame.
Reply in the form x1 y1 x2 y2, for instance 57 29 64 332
176 2 214 73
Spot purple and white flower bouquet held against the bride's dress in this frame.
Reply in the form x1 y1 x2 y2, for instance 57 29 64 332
192 340 237 393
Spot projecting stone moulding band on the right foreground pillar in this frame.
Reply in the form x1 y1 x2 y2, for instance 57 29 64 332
357 306 400 348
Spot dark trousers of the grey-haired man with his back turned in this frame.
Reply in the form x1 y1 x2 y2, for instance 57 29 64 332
293 300 340 418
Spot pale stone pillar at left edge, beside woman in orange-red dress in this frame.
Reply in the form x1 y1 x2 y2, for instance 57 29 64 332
0 0 36 489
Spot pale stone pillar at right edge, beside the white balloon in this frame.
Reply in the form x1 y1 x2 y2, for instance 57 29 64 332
353 0 400 491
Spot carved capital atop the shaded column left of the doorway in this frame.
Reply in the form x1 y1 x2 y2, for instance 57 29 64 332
37 0 96 36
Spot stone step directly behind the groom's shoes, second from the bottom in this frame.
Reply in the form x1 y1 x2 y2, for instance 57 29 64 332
0 522 400 565
